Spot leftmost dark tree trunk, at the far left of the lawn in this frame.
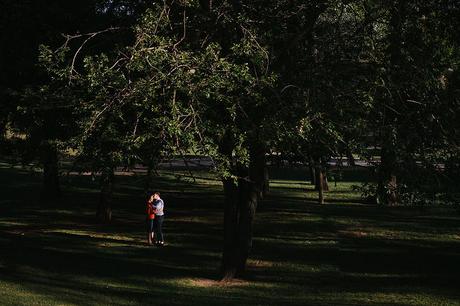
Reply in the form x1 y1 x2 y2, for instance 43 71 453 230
41 141 61 200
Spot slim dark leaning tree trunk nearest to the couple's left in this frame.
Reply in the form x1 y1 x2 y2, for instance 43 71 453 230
96 166 115 223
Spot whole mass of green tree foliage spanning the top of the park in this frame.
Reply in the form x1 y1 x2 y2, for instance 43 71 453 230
2 1 460 203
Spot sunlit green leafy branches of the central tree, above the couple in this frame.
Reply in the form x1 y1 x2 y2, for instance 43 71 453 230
36 1 274 176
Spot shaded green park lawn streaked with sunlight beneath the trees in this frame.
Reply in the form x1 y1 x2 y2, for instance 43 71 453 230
0 164 460 305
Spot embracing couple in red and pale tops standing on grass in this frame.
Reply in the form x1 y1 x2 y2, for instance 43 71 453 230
147 192 164 246
